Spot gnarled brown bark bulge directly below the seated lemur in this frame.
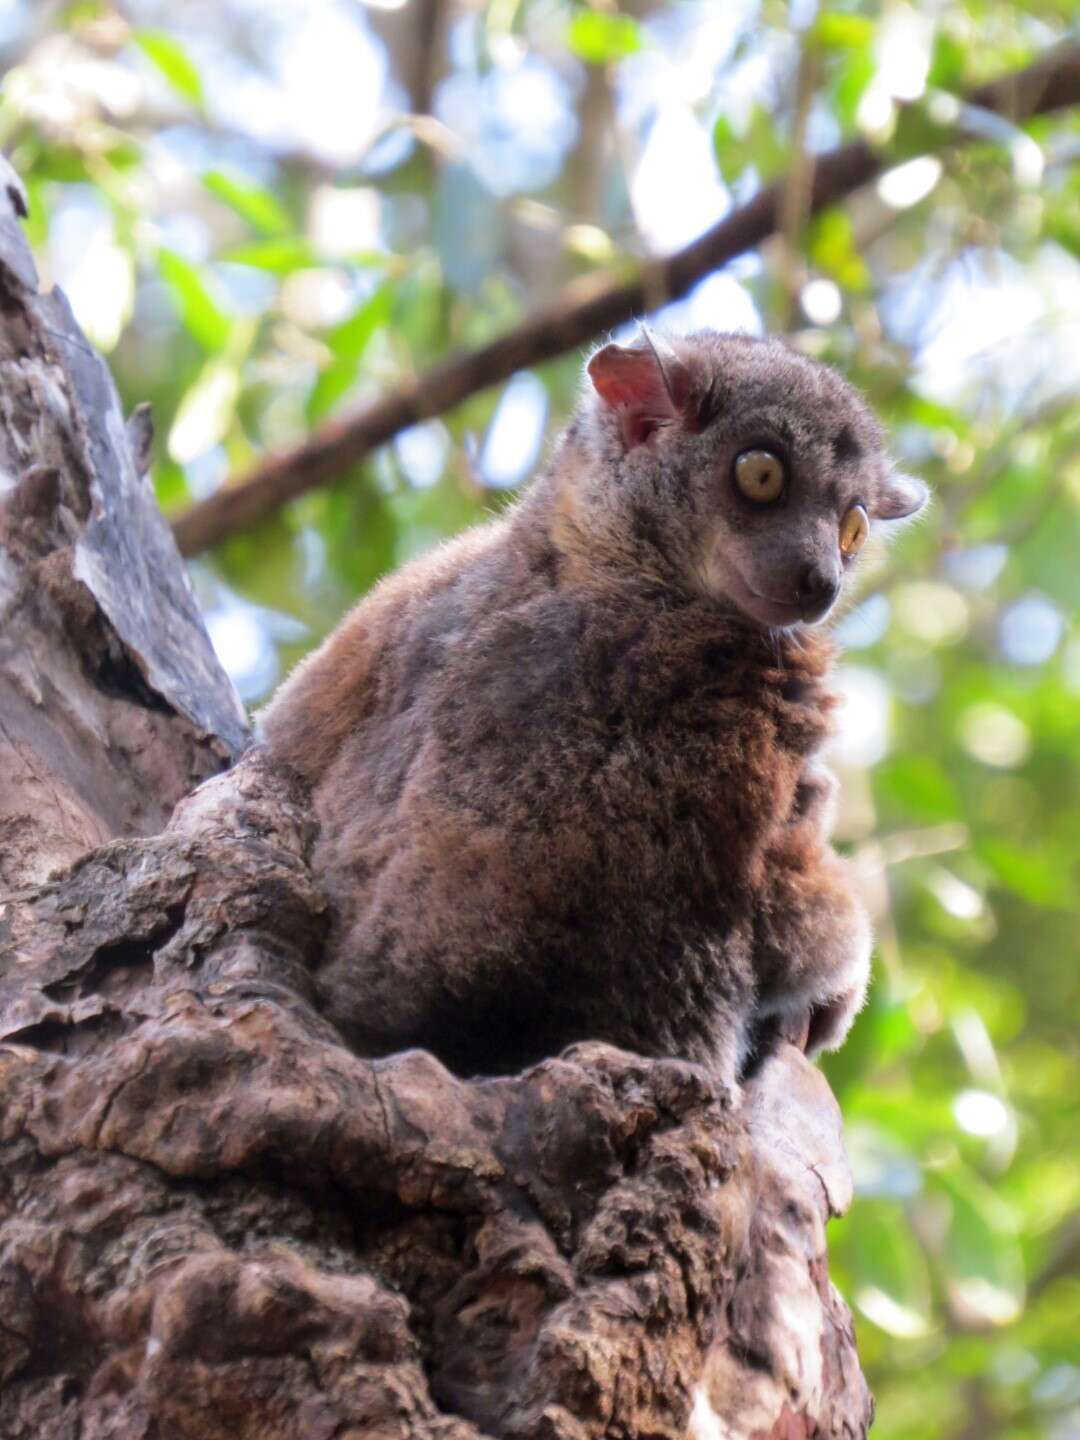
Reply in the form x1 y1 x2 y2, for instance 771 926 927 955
0 752 868 1440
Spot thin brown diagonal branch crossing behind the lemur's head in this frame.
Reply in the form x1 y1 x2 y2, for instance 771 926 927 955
173 40 1080 556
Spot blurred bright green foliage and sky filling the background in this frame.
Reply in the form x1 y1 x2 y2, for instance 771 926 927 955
0 0 1080 1440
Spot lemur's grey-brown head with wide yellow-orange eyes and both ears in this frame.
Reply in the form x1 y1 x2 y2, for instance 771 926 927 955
572 331 927 626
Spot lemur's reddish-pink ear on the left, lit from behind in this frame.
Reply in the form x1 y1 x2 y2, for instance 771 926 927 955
588 325 693 449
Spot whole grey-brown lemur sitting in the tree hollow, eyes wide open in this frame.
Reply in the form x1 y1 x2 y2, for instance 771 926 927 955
262 331 926 1090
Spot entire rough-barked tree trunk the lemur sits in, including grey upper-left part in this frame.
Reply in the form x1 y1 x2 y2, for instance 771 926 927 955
0 160 870 1440
